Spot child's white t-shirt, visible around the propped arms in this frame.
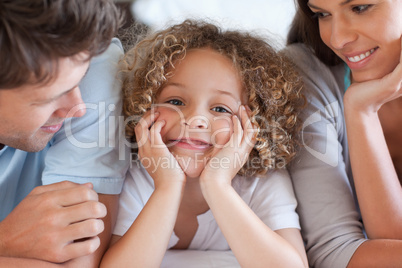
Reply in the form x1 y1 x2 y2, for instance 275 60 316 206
113 162 300 250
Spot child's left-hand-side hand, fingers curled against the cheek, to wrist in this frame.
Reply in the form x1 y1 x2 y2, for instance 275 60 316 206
135 112 186 189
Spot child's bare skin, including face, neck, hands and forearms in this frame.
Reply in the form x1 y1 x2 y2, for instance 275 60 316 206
101 49 308 267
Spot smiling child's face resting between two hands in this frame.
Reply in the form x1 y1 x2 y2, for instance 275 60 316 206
157 49 245 178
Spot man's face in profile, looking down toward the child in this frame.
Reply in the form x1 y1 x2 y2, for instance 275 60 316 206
0 53 89 152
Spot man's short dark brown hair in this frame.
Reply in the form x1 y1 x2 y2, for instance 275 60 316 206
0 0 120 89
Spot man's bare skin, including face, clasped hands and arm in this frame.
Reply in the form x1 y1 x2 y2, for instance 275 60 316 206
0 53 118 267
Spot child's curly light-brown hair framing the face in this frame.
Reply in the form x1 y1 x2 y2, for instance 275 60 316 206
123 20 305 176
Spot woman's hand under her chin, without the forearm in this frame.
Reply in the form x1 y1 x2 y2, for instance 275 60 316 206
344 38 402 113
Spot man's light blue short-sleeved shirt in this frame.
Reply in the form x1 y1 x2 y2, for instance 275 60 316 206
0 39 129 220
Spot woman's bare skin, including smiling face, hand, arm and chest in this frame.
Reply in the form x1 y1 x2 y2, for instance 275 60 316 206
309 0 402 267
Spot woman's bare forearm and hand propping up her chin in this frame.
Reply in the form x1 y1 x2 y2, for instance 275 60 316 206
344 35 402 240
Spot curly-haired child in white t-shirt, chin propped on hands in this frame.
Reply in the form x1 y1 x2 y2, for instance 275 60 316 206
102 21 307 267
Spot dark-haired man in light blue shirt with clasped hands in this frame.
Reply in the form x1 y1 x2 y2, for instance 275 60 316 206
0 0 128 267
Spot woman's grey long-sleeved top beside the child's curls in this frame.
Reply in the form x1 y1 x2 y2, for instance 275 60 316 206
284 44 366 268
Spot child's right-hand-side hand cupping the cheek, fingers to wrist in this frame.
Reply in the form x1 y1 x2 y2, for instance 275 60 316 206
200 105 256 185
